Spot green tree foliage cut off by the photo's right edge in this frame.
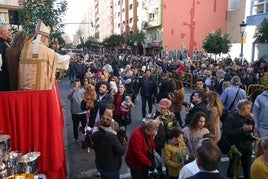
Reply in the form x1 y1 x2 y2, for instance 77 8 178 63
255 19 268 43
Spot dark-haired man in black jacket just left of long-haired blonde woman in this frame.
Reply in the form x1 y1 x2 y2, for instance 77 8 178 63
185 90 208 124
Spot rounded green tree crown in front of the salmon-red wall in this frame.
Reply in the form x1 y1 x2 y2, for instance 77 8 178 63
203 29 232 54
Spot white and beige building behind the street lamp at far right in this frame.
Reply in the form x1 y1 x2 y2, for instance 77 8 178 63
227 0 268 62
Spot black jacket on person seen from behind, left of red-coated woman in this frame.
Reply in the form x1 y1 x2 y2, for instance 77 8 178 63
91 127 126 171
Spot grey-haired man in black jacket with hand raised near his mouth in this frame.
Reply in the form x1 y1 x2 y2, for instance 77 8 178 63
221 99 254 179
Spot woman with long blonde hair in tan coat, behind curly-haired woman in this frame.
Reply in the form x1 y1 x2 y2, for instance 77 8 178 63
207 92 223 142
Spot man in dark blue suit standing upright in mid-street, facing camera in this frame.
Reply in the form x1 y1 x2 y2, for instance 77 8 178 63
140 70 157 119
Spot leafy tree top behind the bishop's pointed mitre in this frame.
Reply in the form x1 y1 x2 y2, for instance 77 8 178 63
19 0 67 39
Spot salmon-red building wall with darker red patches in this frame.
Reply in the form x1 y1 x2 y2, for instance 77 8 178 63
163 0 228 56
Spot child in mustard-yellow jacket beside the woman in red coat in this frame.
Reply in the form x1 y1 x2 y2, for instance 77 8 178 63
164 127 187 179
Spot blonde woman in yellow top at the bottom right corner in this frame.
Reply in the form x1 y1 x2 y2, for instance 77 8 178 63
250 136 268 179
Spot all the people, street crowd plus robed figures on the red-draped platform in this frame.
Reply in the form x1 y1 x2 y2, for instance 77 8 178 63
0 20 268 179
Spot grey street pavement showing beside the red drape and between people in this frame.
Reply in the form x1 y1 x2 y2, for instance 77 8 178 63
58 78 228 179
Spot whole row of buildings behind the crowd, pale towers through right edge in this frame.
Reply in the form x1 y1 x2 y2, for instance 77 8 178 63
74 0 268 61
